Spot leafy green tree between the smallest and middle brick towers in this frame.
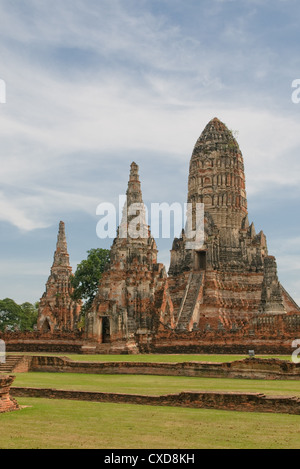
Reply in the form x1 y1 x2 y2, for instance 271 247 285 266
71 248 110 313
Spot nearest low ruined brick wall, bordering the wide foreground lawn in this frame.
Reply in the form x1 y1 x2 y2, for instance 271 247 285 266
12 388 300 415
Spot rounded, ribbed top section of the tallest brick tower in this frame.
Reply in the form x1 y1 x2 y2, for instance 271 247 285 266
188 117 248 229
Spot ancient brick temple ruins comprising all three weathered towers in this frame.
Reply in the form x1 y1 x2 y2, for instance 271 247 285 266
29 118 300 353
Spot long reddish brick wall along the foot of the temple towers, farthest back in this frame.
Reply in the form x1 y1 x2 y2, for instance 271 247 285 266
0 328 300 355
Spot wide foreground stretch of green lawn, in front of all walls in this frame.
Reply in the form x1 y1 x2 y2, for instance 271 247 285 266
0 398 300 448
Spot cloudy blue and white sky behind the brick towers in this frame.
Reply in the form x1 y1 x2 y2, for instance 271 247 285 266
0 0 300 303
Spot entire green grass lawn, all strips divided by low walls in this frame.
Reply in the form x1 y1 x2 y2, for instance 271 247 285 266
0 354 300 449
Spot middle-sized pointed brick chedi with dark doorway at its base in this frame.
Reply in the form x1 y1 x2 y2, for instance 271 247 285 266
86 163 172 352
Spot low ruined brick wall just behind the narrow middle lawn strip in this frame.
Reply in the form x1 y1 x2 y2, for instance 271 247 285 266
28 356 300 380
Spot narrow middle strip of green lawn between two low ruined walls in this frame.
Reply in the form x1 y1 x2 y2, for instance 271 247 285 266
14 373 300 397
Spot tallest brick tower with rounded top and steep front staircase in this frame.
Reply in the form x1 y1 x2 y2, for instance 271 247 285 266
169 118 299 331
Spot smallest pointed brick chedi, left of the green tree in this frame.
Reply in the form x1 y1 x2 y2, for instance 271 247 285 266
38 222 81 333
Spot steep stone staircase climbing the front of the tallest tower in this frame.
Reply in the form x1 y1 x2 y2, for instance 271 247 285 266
176 272 204 330
